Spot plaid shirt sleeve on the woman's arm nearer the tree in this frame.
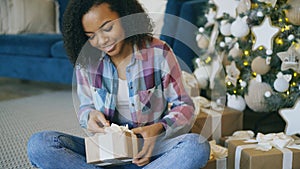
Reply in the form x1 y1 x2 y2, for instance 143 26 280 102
161 45 195 137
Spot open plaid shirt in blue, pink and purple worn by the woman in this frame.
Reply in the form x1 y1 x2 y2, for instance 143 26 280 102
76 39 194 135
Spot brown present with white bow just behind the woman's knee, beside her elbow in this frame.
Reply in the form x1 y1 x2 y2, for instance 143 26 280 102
191 96 243 143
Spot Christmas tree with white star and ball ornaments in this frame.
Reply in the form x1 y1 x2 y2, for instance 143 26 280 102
195 0 300 112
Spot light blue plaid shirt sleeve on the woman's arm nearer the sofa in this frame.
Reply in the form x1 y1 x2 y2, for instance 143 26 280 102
76 66 95 128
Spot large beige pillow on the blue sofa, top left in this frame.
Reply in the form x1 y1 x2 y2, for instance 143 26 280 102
6 0 59 34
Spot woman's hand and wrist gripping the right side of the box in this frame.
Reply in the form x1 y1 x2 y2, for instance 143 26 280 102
132 123 164 166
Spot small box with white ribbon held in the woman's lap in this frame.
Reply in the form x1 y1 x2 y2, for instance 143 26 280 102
85 124 138 166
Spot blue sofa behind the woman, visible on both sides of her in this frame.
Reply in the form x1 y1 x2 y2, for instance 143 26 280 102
0 0 206 84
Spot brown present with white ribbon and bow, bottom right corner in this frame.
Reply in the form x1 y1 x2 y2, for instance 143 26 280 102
228 133 300 169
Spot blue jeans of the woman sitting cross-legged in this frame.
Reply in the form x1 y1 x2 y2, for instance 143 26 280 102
27 131 210 169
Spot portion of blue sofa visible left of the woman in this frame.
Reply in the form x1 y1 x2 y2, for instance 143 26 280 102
0 0 73 84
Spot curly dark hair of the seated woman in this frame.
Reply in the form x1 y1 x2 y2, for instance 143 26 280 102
62 0 153 66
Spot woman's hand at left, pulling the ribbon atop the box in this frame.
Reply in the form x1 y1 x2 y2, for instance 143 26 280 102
87 110 110 133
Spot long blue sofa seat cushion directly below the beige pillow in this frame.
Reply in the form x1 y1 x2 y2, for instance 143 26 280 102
0 34 62 57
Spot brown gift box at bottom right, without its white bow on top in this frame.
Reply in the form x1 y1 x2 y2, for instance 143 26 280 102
228 140 300 169
